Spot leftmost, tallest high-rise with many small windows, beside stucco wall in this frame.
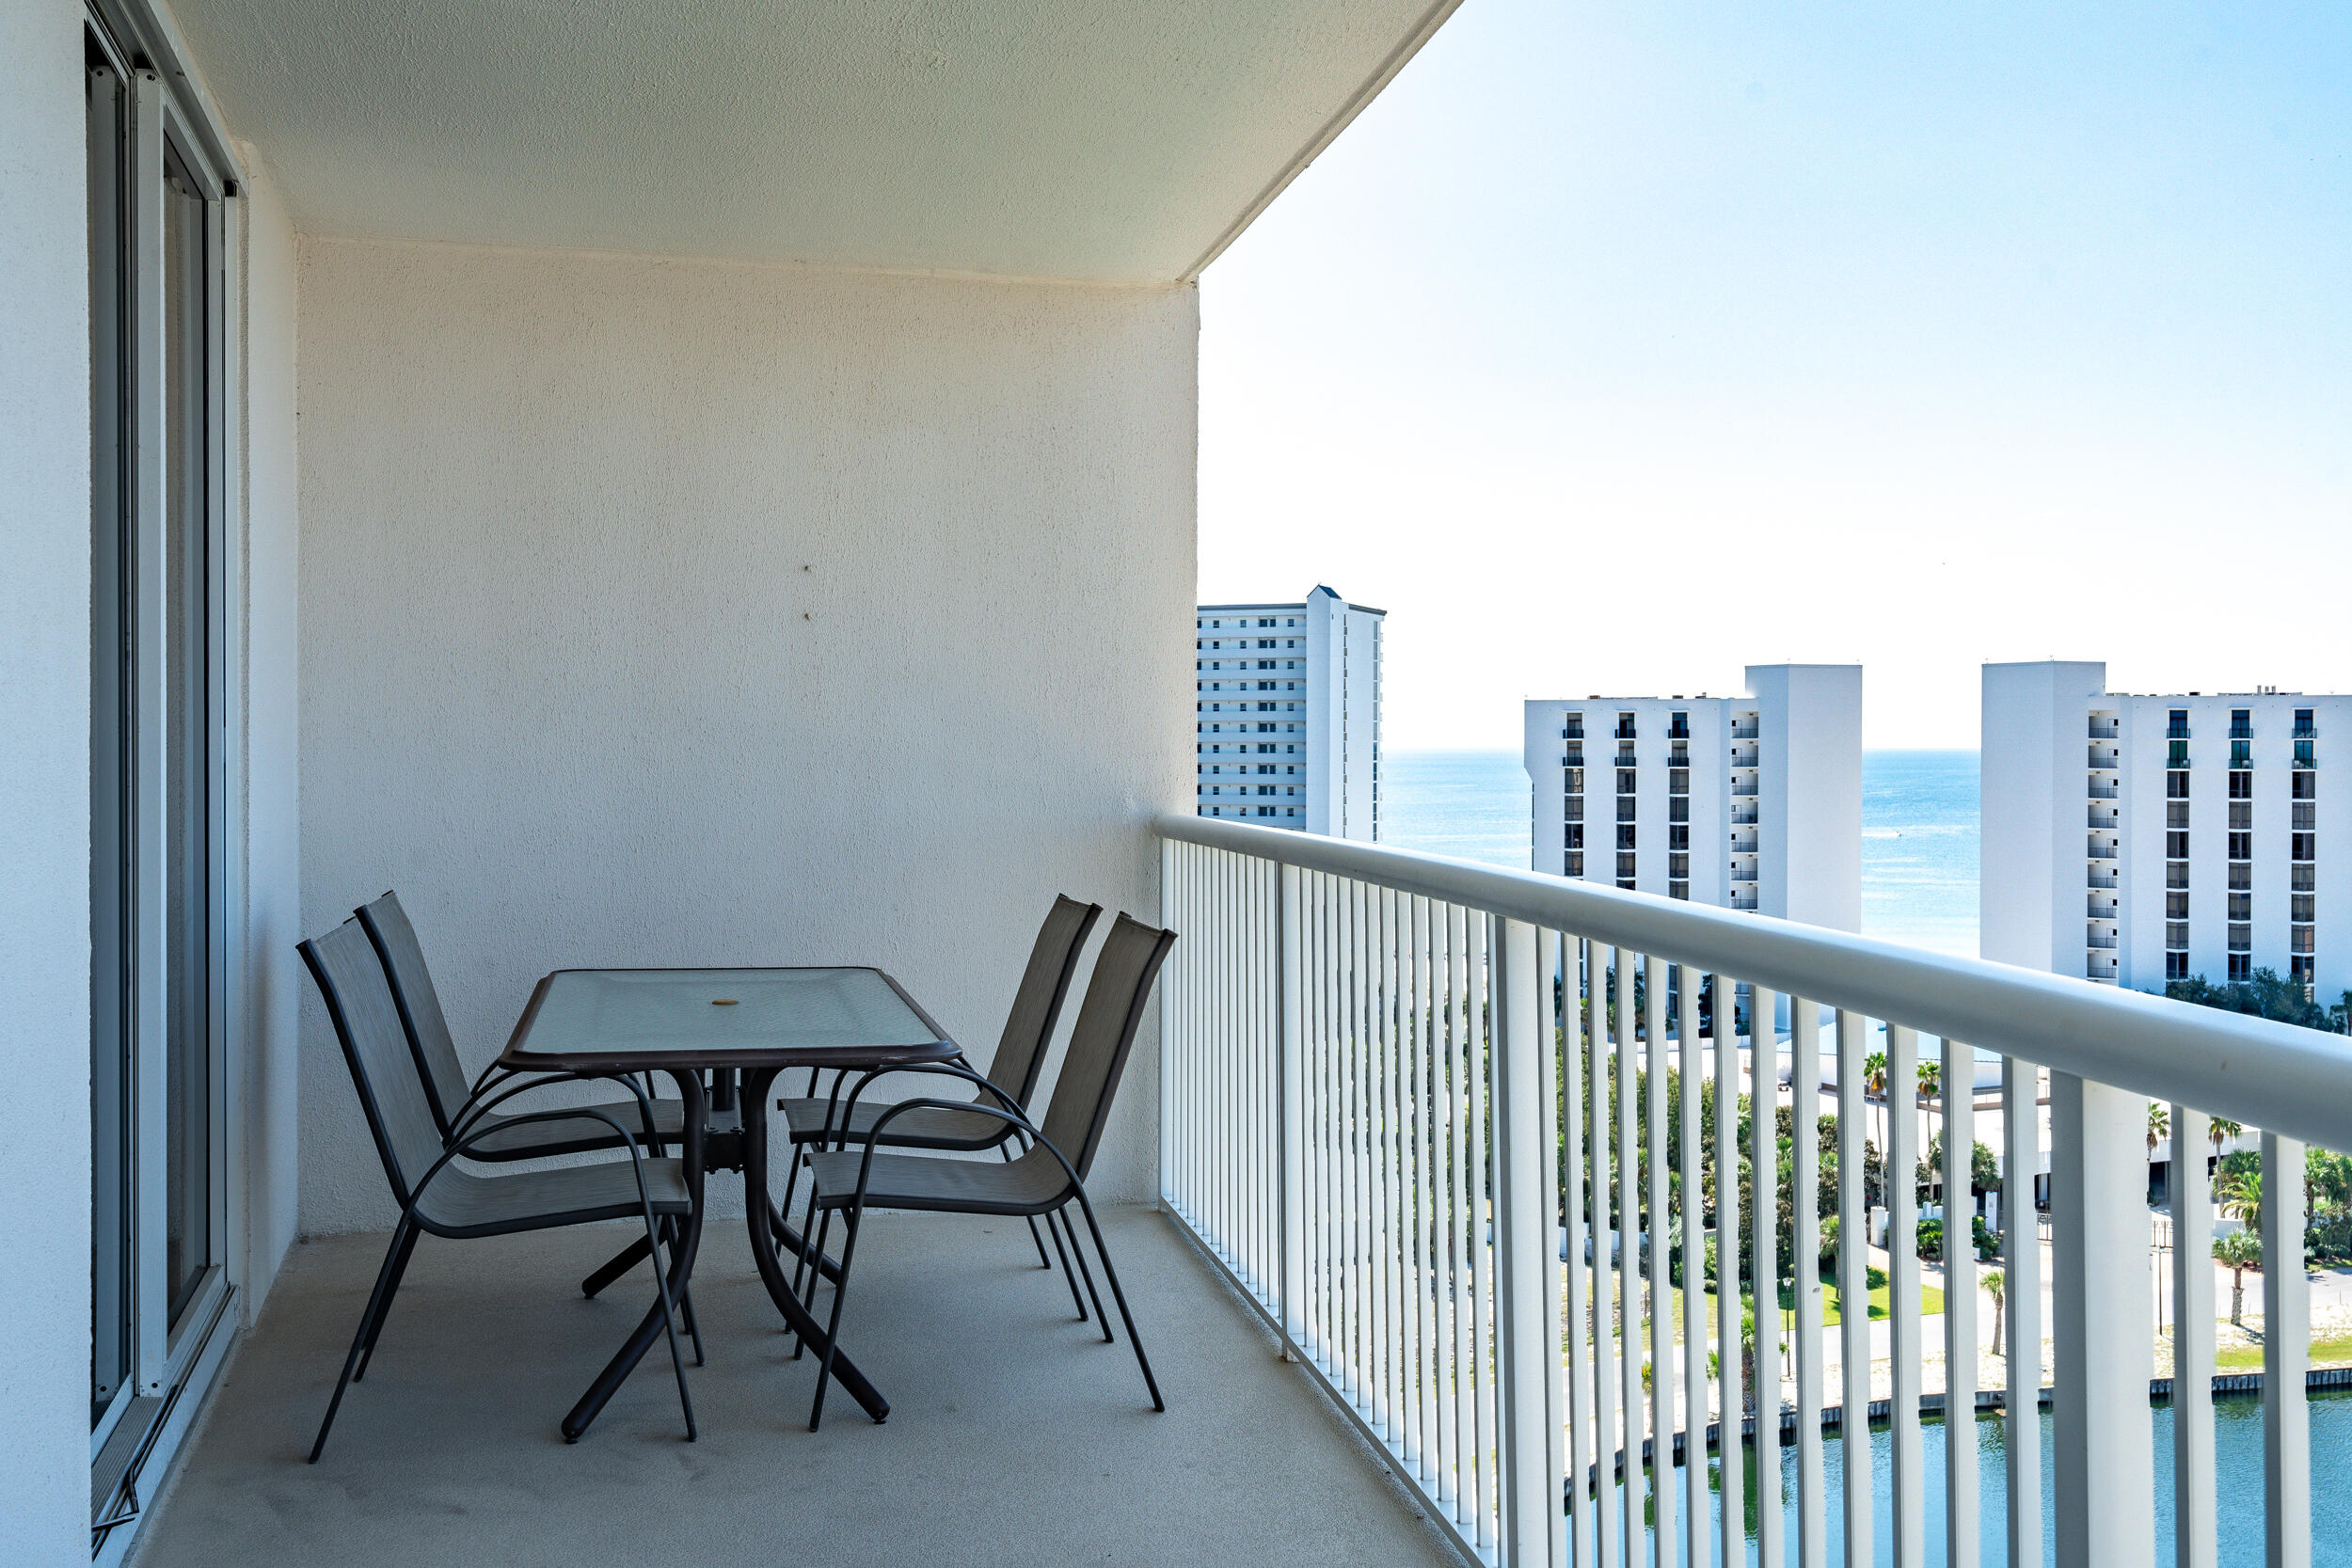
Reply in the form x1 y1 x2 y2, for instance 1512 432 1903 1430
1193 588 1388 839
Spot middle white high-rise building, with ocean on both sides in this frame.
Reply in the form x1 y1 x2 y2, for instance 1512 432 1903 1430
1527 665 1863 931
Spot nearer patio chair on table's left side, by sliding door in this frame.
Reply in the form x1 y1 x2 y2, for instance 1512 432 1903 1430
296 919 694 1465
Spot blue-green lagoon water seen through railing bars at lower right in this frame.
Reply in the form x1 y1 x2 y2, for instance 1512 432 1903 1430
1609 1389 2352 1568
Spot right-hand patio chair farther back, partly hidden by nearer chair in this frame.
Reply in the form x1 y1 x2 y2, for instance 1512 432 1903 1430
776 895 1104 1317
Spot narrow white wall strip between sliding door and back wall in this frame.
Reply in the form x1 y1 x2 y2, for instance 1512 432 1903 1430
233 148 309 1323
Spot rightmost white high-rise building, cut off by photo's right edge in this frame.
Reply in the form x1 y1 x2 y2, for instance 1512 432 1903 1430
1980 660 2352 997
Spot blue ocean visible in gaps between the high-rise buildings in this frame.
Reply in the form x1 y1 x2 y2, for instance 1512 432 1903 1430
1381 752 1979 957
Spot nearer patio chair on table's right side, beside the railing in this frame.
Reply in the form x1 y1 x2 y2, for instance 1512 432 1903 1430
804 914 1176 1432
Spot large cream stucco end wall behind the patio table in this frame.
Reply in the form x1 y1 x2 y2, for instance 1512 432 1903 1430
301 240 1198 1232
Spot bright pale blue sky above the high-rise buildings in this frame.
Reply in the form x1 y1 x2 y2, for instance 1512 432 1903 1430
1200 0 2352 748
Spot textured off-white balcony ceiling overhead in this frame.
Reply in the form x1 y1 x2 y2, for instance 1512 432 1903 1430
172 0 1458 282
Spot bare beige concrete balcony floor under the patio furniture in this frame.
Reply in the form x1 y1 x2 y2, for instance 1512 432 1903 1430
135 1211 1458 1568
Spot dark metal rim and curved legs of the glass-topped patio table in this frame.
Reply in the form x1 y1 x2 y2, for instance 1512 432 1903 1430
494 964 962 1441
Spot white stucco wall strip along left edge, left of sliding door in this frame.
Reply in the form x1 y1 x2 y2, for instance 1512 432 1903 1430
0 0 89 1568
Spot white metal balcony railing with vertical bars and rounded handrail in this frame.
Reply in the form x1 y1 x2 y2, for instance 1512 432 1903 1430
1155 816 2352 1568
